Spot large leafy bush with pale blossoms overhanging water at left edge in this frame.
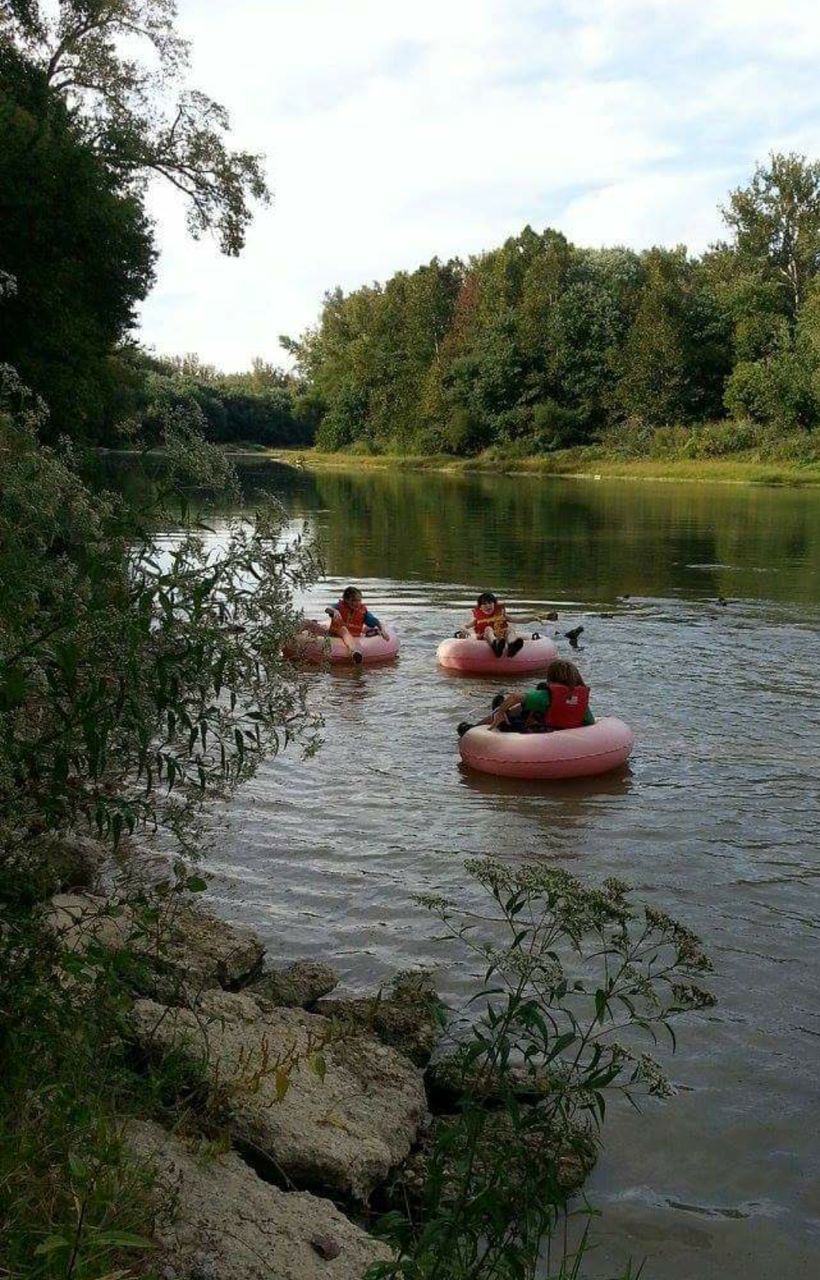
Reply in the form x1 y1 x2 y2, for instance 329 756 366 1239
0 371 315 875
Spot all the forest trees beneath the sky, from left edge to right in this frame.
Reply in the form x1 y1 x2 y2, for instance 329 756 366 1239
0 5 820 462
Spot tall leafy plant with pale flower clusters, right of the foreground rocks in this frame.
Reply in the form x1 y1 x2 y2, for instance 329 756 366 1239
370 859 714 1280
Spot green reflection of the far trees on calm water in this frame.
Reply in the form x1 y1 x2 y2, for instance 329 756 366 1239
228 465 820 607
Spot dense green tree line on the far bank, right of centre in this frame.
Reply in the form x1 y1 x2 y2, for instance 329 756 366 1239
281 155 820 454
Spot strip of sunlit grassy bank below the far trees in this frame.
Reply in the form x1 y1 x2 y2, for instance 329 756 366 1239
230 445 820 486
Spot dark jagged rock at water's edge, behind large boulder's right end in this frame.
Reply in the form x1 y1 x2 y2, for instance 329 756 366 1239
316 970 444 1066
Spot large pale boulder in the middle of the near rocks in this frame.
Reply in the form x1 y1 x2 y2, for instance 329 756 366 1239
132 991 427 1201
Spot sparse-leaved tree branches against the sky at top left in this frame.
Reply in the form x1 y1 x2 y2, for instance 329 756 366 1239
0 0 270 255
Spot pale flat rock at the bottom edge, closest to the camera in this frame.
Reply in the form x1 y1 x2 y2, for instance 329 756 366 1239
127 1121 390 1280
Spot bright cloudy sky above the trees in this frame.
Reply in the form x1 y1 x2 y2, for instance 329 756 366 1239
138 0 820 370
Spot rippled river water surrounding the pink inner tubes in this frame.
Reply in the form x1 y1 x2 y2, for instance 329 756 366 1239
181 466 820 1280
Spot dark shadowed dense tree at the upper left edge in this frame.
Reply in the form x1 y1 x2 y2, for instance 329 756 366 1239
0 41 155 434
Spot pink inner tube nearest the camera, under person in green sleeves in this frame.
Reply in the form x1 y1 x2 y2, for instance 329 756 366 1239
458 716 635 778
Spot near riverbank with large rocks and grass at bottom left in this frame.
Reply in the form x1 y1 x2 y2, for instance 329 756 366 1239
0 836 597 1280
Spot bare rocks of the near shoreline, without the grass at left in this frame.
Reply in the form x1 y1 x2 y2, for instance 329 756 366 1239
38 841 594 1280
